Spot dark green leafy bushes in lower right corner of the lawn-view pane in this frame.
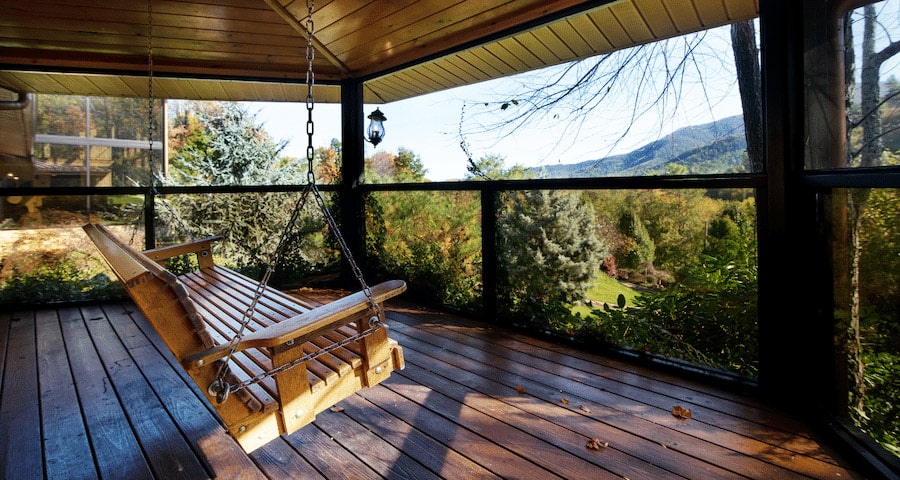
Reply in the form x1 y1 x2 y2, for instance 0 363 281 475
561 195 758 376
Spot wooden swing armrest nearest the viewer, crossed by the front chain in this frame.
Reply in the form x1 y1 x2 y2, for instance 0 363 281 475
182 280 406 371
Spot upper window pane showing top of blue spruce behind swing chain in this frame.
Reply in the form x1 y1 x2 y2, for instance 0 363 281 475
167 100 341 185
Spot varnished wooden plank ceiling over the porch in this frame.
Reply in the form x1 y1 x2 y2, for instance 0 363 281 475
0 0 759 103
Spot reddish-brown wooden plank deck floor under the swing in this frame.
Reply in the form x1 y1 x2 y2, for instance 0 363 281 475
0 294 862 480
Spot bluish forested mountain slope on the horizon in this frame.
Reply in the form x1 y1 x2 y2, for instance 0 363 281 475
538 115 747 178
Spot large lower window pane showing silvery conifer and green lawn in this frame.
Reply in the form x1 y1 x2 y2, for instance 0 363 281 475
497 190 758 376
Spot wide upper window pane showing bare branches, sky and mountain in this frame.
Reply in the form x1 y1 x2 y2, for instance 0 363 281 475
366 21 762 182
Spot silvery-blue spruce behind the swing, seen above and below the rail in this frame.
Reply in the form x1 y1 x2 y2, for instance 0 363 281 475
157 103 339 284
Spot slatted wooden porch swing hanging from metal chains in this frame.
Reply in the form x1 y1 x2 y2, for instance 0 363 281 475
83 2 406 453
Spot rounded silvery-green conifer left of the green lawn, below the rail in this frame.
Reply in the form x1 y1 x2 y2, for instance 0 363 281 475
497 190 608 323
